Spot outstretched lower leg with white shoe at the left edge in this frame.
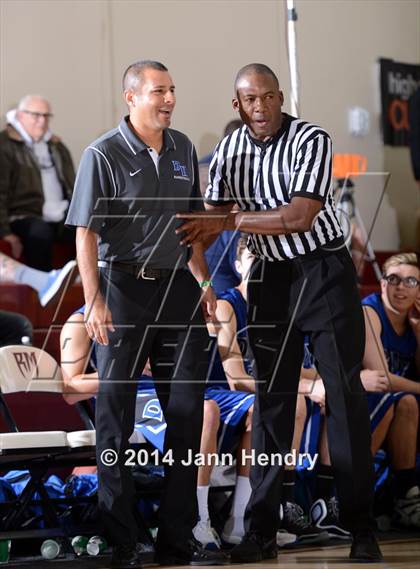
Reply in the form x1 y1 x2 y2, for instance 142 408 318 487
0 252 78 307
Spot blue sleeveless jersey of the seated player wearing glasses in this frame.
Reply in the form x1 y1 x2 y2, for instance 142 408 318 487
362 293 418 380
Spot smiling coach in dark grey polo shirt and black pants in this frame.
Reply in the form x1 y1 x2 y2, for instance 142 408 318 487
67 61 225 568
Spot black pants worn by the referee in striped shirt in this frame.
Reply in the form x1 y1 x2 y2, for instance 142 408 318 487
246 248 374 536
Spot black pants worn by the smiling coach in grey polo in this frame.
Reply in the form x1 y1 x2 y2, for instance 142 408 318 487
96 269 208 551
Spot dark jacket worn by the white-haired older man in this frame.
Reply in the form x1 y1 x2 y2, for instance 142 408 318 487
0 125 75 238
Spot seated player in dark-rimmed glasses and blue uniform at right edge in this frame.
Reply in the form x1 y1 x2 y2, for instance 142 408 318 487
362 253 420 528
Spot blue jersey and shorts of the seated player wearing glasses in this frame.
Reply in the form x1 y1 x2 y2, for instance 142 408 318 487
362 293 419 432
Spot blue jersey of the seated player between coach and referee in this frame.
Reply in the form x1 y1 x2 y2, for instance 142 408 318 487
207 288 254 389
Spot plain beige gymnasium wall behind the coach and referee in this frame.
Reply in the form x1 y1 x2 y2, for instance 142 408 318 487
0 0 420 249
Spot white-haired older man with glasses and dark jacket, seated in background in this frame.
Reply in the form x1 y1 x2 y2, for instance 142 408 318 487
0 95 75 271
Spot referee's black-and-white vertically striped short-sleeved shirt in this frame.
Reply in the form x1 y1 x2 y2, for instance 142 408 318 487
205 114 342 260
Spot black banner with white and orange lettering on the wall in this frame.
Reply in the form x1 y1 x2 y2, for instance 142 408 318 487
379 59 420 146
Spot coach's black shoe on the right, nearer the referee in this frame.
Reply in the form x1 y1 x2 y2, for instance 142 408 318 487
155 538 229 567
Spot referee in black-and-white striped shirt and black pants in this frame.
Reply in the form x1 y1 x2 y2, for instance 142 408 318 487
178 63 382 563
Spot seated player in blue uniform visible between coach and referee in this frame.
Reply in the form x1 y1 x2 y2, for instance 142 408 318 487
194 238 255 547
